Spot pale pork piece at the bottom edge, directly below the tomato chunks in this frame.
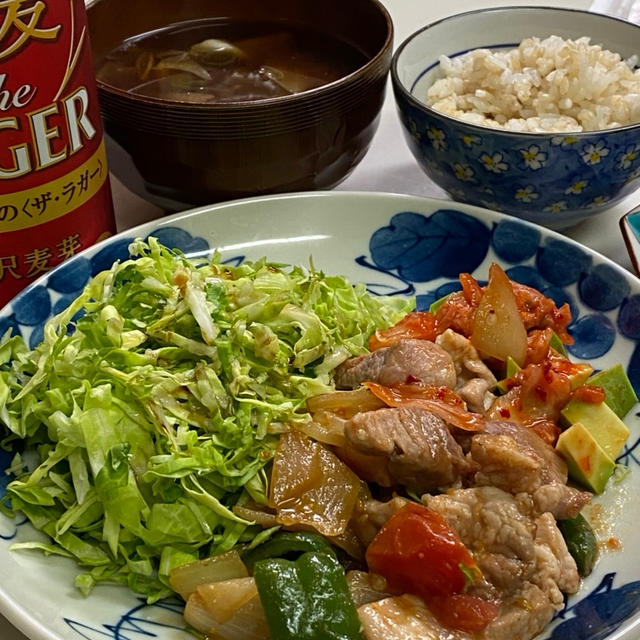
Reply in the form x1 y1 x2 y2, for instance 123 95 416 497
358 595 472 640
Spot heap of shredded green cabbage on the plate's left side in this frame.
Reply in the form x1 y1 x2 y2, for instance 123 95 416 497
0 238 414 601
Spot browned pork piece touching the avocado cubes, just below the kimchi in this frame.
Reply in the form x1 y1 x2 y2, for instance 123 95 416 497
469 421 591 519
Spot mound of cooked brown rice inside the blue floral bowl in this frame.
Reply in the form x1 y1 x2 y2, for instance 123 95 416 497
427 36 640 132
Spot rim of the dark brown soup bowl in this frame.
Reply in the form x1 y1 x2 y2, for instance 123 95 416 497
92 0 395 112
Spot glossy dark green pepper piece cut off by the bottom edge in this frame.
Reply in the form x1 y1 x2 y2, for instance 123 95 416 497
253 551 362 640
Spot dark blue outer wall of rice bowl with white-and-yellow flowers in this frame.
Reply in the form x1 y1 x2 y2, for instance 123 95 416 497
392 98 640 228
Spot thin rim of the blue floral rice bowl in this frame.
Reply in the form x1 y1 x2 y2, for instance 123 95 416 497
390 5 640 139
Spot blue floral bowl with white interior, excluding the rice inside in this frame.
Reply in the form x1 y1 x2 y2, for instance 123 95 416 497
391 7 640 229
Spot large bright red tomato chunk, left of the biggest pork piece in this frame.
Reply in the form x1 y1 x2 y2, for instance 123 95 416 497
366 502 477 601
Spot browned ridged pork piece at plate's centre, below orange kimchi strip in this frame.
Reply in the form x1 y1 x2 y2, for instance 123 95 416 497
344 407 469 493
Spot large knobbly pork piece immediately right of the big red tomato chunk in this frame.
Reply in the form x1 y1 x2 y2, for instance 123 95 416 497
422 487 580 639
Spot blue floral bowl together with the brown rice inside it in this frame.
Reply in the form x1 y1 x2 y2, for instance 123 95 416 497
391 6 640 229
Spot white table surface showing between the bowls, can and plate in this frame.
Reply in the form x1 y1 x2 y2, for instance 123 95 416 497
0 0 640 640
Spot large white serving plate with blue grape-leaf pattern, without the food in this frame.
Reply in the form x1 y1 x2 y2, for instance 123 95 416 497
0 192 640 640
